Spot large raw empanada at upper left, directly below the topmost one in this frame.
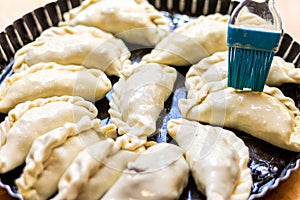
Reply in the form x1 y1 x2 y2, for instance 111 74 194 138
13 26 130 76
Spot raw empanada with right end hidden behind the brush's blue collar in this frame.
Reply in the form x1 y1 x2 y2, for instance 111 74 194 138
142 13 229 66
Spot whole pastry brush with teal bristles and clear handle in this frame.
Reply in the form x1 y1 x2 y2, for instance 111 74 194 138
227 0 282 92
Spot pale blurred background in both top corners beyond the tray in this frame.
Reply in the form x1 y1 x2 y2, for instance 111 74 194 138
0 0 300 42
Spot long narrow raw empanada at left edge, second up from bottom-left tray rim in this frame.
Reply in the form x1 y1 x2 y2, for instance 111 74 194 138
0 63 111 113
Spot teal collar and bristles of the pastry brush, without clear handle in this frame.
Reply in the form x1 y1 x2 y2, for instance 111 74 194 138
227 26 281 92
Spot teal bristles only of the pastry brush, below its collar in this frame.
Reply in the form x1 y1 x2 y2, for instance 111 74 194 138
228 47 274 91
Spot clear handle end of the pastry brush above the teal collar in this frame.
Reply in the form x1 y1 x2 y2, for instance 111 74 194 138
229 0 282 32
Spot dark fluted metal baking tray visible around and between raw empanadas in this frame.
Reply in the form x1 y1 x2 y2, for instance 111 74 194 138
0 0 300 200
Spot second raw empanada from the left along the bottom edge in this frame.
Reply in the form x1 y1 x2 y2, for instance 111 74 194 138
53 140 138 200
